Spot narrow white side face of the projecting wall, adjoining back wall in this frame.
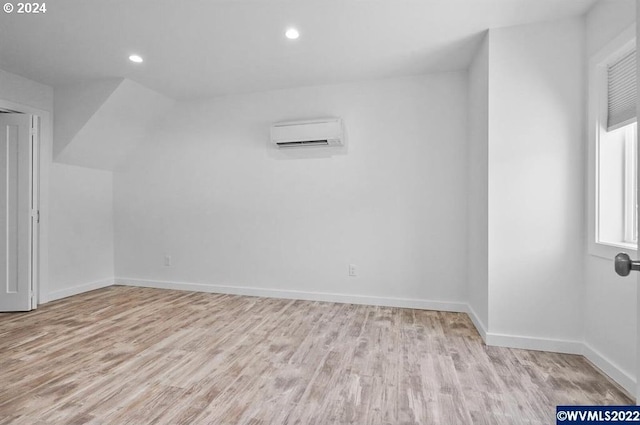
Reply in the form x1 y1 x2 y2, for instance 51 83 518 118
467 33 489 337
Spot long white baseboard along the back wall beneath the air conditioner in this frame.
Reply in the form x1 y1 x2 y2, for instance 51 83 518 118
115 278 467 313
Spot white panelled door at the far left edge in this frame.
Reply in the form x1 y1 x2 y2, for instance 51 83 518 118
0 113 36 311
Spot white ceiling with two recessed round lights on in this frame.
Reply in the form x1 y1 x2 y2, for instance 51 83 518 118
0 0 594 99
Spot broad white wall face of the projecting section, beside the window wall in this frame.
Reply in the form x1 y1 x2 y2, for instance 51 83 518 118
488 18 585 352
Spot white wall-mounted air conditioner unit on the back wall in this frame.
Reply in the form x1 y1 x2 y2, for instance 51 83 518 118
271 118 344 148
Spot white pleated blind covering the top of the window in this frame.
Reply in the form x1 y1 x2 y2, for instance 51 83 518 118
607 50 636 131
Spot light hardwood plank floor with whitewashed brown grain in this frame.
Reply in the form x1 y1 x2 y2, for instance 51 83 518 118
0 287 632 425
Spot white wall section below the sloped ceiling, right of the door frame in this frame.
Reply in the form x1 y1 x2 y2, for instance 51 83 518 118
49 163 114 299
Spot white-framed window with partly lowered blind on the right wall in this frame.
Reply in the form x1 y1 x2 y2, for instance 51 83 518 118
588 28 638 258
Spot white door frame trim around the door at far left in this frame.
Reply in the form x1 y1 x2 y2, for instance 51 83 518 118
0 99 53 309
